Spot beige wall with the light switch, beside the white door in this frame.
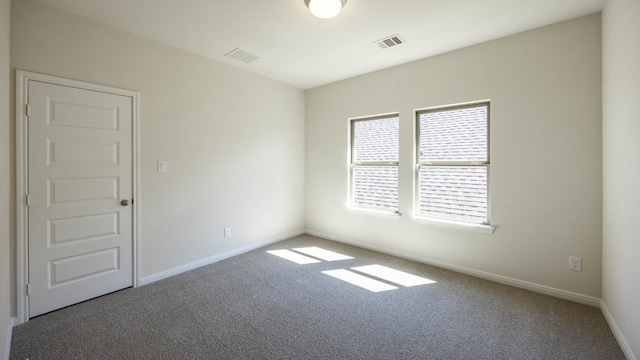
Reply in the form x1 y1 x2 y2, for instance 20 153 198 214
11 0 304 312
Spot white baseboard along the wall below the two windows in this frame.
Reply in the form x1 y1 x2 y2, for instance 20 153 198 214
306 229 600 307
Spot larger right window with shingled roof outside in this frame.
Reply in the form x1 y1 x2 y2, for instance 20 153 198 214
415 102 489 224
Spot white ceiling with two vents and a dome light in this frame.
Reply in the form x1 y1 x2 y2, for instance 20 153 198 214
33 0 606 89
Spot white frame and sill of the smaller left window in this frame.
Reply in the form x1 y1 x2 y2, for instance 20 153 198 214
347 112 400 217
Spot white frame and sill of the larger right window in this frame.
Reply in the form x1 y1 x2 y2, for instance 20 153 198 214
412 100 495 234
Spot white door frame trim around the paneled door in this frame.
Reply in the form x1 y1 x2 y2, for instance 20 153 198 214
15 70 141 325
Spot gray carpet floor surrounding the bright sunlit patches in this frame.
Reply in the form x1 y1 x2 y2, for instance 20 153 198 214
10 235 624 360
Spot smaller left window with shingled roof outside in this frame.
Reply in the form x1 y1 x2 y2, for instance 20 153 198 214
349 114 399 213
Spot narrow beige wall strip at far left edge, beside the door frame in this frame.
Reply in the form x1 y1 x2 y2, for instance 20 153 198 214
0 0 12 359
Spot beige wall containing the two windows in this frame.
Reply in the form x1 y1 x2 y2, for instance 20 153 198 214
306 14 602 303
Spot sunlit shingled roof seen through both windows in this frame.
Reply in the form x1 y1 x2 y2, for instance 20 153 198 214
352 104 488 223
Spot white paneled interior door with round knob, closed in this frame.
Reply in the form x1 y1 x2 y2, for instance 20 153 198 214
27 80 133 317
